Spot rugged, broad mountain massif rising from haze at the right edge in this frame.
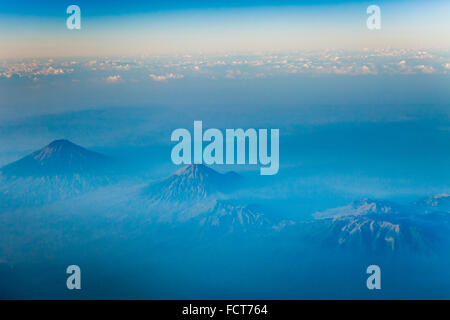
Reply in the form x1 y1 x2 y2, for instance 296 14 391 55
314 195 450 253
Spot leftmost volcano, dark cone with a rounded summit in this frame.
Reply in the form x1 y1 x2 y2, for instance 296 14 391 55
0 140 112 209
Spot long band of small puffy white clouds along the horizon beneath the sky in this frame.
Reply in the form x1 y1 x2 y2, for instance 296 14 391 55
0 49 450 83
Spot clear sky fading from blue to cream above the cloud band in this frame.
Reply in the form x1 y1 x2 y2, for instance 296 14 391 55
0 0 450 59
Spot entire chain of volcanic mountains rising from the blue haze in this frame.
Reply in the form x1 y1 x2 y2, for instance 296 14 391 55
0 140 450 253
